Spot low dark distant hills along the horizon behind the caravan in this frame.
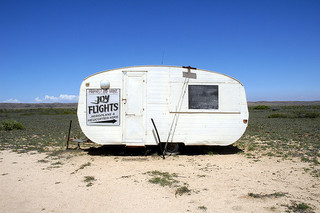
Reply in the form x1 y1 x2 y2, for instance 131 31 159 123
0 101 320 109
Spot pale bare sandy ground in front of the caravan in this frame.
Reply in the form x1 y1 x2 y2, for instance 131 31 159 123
0 150 320 212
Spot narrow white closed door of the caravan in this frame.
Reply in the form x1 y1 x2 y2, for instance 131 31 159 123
122 71 147 146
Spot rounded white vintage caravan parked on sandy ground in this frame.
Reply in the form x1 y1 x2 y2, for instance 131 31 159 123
78 66 249 146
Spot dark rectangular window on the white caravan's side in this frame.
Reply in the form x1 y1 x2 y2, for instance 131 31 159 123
188 85 218 109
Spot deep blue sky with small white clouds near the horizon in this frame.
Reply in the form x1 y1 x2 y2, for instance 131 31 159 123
0 0 320 103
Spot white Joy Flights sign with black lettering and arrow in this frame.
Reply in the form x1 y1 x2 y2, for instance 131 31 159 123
87 89 120 126
